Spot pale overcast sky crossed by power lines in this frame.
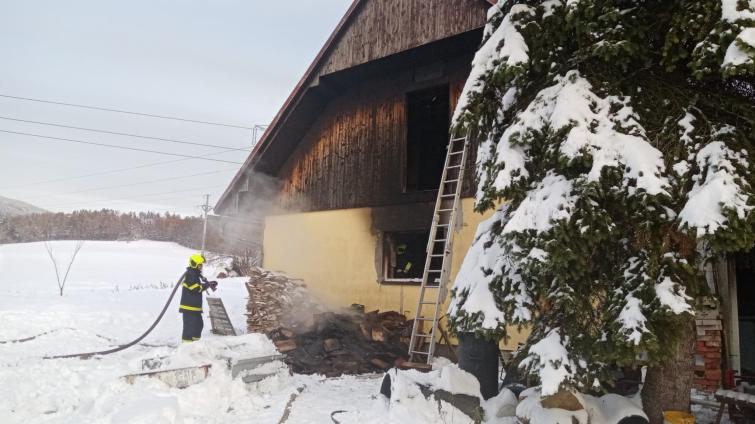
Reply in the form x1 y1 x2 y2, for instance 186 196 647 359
0 0 351 215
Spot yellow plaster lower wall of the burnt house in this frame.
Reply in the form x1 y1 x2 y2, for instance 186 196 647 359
263 199 524 349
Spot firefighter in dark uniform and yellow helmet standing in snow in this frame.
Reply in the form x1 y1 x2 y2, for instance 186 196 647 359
178 254 218 343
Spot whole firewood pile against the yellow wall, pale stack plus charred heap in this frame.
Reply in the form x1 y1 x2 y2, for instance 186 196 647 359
246 267 413 377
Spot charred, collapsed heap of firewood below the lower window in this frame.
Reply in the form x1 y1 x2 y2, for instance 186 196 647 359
270 311 412 377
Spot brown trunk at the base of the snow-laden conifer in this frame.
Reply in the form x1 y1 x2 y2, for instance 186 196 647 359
642 314 695 424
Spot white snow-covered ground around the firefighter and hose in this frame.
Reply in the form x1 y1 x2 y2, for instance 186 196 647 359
0 241 386 424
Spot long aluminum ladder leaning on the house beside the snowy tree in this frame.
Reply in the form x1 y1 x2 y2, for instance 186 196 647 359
409 136 469 364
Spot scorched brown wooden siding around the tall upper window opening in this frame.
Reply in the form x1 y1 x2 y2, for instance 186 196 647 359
277 58 474 211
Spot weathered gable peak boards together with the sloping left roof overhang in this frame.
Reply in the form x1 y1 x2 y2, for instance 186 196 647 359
216 0 496 214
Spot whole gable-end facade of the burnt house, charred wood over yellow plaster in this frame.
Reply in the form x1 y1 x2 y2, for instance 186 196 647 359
216 0 519 352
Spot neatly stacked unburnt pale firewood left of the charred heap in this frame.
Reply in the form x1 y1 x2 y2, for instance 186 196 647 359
246 267 324 334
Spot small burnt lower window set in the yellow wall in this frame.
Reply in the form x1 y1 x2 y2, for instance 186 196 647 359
383 231 430 283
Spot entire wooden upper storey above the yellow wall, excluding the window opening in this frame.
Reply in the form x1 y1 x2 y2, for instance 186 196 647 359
216 0 490 215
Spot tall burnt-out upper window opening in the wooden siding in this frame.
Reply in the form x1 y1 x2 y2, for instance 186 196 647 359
405 85 451 192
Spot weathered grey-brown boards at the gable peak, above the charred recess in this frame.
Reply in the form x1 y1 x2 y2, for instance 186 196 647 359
317 0 487 75
